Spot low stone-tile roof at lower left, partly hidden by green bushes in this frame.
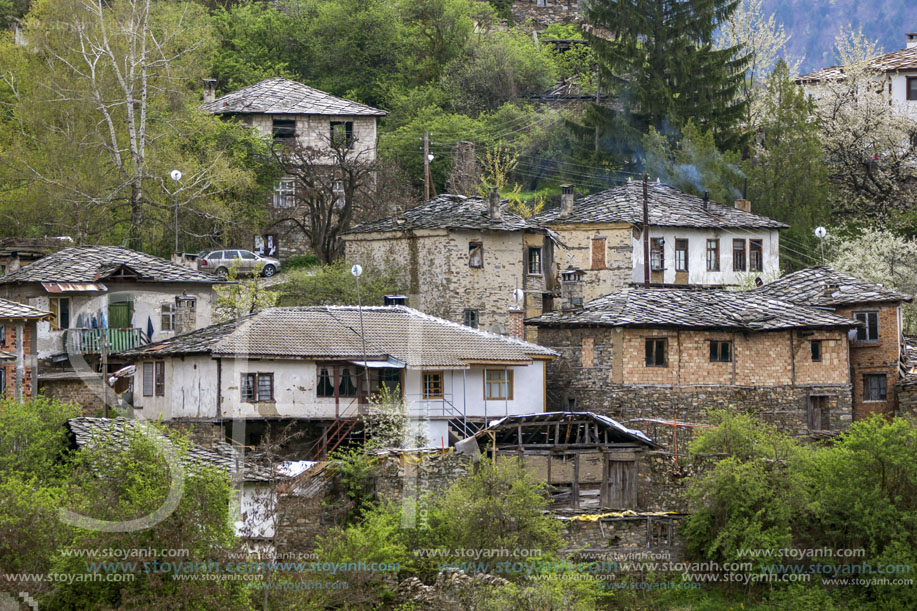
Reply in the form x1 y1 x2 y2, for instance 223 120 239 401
67 418 276 482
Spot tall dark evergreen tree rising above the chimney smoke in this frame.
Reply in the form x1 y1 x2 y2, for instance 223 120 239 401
586 0 748 160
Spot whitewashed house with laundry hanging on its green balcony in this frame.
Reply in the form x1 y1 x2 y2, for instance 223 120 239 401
0 246 219 407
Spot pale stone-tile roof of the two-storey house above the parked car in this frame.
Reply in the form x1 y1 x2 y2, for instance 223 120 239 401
201 77 388 117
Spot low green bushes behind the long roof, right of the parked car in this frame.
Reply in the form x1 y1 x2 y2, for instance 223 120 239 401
277 260 407 306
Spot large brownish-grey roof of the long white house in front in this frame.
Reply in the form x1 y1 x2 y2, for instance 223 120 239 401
121 306 557 368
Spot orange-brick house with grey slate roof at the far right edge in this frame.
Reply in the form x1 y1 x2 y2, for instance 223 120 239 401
753 268 917 420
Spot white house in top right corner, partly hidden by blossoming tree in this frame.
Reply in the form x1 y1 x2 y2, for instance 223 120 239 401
796 32 917 119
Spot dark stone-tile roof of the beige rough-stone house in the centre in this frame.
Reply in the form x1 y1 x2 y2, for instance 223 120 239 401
346 195 538 234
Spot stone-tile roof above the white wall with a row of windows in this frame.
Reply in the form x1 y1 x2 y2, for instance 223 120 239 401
530 181 789 229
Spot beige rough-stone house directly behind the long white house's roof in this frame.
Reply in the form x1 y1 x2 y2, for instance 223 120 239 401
343 190 558 339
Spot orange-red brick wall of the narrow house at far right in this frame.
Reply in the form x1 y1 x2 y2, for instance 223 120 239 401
836 303 903 420
